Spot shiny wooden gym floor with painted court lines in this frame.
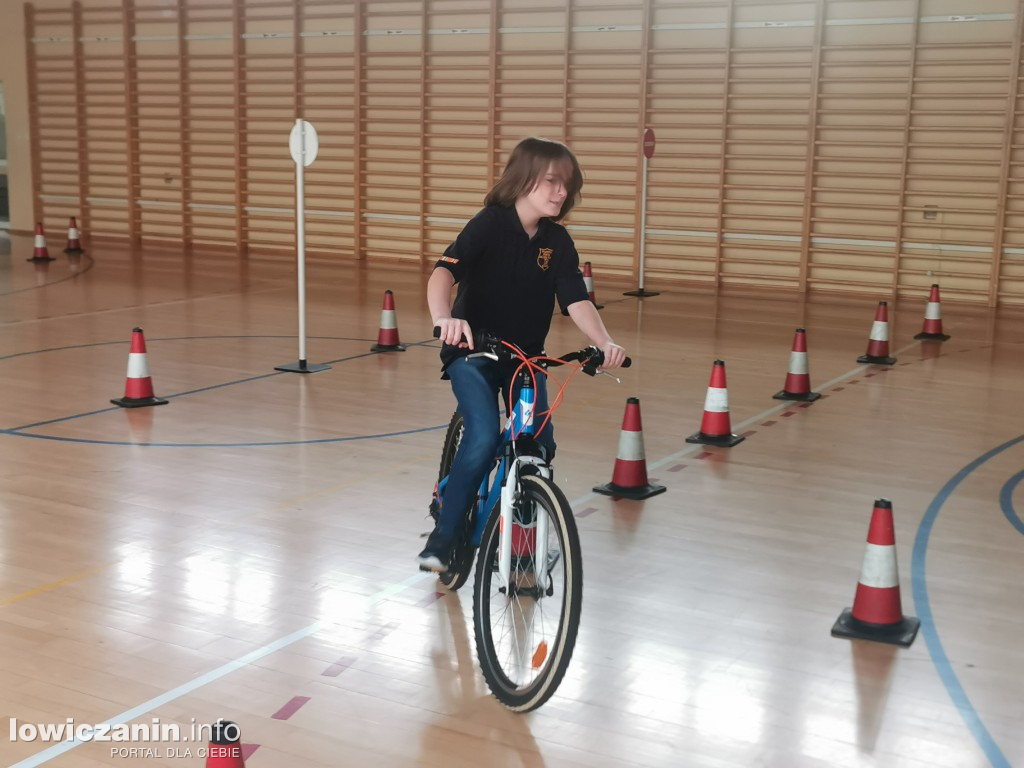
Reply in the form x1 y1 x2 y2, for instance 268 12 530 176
0 230 1024 768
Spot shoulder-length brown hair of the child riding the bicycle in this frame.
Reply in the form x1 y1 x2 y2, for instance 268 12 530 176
483 136 583 221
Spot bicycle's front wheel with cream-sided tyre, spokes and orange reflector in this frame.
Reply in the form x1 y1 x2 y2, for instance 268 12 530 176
473 475 583 712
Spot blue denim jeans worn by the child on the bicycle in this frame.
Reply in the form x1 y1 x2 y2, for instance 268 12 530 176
436 357 555 540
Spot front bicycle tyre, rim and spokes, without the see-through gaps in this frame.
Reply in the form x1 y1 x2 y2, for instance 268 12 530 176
473 475 583 712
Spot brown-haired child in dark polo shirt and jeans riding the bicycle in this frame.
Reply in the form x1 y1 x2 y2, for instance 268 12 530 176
418 138 626 571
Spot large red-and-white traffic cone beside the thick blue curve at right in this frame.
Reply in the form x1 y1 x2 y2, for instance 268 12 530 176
831 499 921 648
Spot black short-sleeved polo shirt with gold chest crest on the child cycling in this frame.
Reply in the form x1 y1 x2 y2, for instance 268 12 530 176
435 206 589 366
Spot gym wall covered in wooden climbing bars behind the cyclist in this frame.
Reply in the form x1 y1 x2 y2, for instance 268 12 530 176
6 0 1024 305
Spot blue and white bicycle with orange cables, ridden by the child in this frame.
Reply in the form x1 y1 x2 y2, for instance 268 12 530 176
421 328 631 712
